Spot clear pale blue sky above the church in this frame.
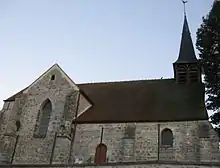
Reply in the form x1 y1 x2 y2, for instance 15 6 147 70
0 0 213 106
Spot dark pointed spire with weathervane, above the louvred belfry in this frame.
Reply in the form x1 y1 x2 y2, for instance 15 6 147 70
175 1 197 63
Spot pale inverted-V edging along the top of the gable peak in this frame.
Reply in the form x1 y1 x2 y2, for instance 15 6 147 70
23 63 79 93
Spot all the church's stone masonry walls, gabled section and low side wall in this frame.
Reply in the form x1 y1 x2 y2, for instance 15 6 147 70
0 65 220 168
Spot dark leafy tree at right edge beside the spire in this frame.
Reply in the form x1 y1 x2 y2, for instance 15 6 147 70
196 0 220 129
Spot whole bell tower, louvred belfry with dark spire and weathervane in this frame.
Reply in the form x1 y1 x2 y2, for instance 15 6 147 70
173 1 201 84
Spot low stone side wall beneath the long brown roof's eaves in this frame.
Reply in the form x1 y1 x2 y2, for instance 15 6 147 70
73 121 220 163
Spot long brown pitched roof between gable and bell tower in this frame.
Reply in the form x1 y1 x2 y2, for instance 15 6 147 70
77 79 208 123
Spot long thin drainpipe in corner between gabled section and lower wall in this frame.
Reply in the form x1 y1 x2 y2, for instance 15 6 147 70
68 91 80 164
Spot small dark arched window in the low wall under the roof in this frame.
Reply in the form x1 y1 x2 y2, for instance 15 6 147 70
161 128 173 147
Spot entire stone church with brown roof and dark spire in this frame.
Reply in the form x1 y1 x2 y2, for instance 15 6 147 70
0 6 220 168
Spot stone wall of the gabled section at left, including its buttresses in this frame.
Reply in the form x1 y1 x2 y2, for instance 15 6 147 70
0 65 90 164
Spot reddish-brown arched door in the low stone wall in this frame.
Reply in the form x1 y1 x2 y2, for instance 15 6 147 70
95 143 107 164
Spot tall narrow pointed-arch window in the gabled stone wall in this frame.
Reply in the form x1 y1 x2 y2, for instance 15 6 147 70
35 99 52 137
